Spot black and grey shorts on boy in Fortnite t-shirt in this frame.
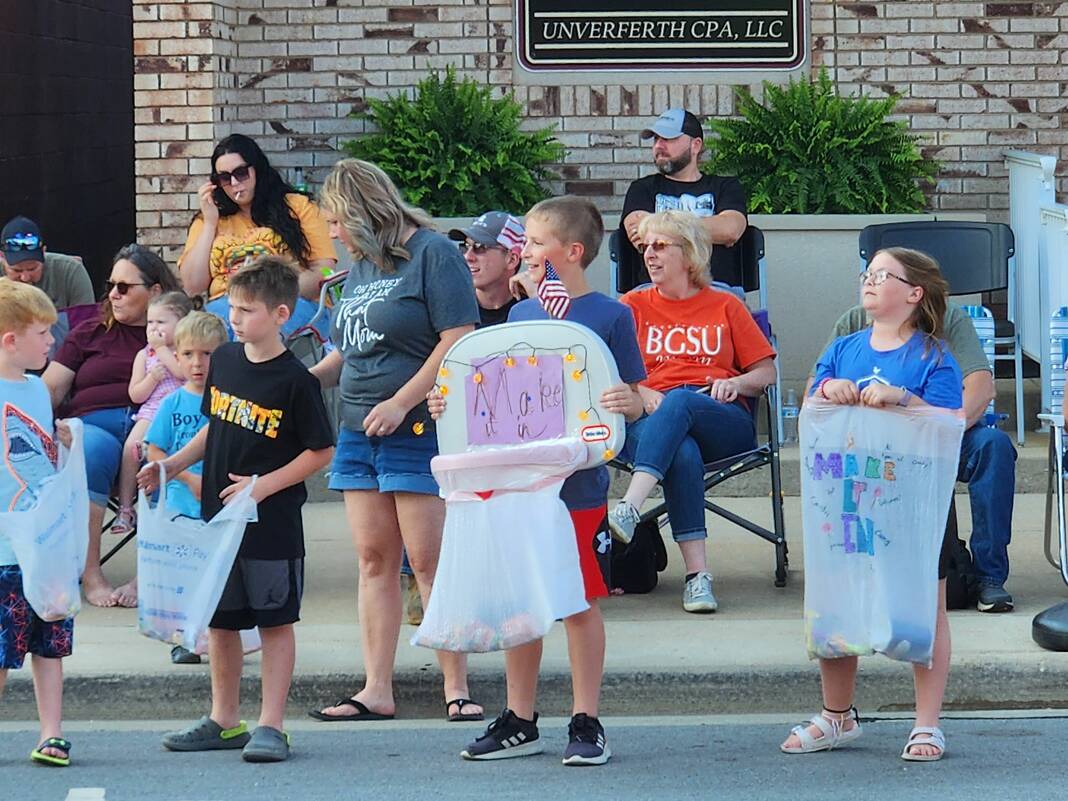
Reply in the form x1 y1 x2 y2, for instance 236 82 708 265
209 556 304 631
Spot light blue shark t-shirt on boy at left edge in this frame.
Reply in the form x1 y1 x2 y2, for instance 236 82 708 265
0 376 59 565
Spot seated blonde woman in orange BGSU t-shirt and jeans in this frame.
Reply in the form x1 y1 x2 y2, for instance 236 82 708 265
609 211 775 612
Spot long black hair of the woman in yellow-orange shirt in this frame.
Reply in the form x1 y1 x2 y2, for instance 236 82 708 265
211 134 308 266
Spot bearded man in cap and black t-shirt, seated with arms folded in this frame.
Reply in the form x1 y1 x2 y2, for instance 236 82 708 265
618 109 749 289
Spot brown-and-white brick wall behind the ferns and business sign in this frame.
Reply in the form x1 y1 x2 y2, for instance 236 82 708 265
134 0 1068 258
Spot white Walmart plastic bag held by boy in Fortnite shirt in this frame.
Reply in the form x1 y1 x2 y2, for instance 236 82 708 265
137 467 257 650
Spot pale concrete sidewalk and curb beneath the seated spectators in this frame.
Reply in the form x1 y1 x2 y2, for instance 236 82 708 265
8 494 1068 719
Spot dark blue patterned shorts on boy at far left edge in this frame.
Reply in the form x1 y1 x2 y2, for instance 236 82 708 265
0 565 74 671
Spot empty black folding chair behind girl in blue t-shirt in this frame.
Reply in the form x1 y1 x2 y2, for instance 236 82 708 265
860 220 1023 445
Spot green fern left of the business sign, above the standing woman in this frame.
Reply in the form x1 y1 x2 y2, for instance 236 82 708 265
342 68 565 217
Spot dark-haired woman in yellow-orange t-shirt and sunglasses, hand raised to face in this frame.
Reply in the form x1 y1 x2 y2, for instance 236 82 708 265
178 134 337 332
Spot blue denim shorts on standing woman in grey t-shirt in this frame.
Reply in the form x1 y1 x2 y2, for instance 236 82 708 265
330 427 438 496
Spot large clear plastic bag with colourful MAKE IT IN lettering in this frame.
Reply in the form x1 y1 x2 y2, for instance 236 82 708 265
800 399 964 665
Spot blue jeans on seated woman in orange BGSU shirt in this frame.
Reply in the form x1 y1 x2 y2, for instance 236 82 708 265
622 387 756 543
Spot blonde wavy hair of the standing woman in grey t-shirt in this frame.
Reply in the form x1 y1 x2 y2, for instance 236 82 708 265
319 158 434 272
